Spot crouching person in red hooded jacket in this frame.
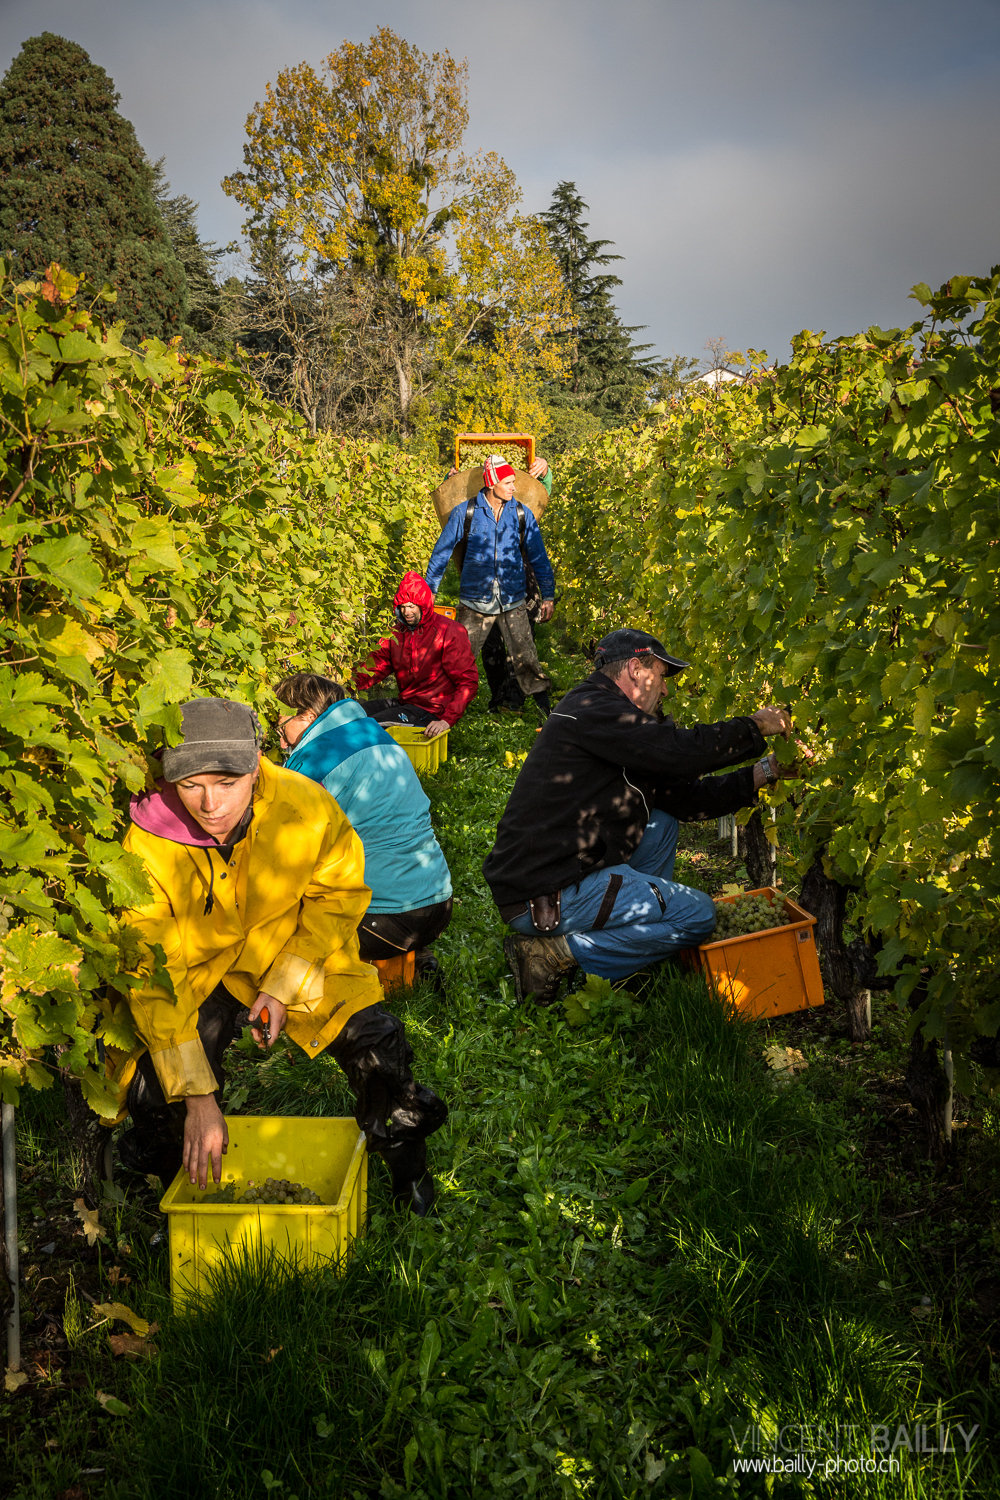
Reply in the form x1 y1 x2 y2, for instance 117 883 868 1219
354 573 480 740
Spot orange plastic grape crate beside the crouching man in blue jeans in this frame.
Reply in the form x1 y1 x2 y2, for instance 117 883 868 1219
697 885 823 1019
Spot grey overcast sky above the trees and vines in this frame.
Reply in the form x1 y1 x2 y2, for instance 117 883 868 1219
0 0 1000 359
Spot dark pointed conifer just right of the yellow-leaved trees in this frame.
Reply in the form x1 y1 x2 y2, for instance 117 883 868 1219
541 182 660 431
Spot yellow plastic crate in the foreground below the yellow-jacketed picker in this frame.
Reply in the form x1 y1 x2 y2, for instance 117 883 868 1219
160 1115 367 1313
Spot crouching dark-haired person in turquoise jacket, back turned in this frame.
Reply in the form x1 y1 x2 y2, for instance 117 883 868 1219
274 672 451 975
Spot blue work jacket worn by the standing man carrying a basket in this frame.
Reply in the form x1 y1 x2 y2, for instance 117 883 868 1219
424 489 556 609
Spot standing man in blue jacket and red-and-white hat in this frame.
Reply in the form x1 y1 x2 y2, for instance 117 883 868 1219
426 453 555 719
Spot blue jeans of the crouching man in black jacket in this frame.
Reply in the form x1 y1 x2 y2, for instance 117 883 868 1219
510 812 715 980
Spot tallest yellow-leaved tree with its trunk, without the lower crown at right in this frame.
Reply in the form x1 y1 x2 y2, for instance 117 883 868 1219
223 27 468 428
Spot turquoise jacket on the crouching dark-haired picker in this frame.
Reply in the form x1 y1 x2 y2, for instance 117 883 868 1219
285 698 451 912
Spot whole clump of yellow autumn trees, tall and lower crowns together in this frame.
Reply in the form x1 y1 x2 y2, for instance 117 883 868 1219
223 27 565 438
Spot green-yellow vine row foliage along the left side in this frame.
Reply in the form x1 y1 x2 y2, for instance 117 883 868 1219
0 267 438 1113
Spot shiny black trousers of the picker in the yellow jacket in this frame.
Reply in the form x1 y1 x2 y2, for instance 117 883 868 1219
120 984 448 1182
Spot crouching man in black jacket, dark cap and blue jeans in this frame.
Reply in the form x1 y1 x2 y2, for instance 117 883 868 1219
483 630 792 1004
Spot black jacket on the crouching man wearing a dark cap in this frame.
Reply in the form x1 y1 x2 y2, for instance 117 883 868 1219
483 672 766 908
